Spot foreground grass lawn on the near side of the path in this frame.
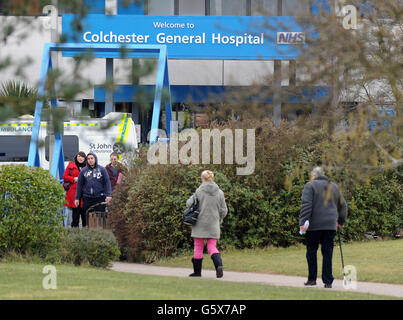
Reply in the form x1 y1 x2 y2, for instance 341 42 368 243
0 262 400 300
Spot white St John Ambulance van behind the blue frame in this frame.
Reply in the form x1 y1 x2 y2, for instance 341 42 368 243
0 112 140 169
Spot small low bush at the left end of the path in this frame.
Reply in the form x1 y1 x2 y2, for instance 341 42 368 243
59 228 120 268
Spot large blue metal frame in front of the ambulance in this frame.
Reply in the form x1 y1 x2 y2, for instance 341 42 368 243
28 43 172 178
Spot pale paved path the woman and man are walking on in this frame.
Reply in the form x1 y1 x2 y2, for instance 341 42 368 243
111 262 403 298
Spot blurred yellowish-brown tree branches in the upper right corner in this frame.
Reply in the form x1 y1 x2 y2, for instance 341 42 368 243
300 0 403 176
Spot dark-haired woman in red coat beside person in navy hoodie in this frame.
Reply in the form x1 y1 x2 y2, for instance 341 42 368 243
63 151 87 228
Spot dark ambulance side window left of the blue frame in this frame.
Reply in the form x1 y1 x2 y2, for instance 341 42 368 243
0 136 31 162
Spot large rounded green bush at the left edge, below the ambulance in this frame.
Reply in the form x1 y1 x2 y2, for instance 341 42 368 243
0 165 64 257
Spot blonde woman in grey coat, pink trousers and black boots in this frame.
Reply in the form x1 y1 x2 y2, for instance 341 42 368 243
186 170 228 278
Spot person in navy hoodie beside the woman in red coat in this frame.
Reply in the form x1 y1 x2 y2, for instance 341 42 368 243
75 152 112 219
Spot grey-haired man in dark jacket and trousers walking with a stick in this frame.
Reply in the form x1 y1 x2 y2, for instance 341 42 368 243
299 167 347 288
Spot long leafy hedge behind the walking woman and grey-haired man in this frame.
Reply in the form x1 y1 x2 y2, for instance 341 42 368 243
111 121 403 262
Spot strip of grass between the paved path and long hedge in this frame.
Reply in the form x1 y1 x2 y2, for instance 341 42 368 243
155 239 403 284
